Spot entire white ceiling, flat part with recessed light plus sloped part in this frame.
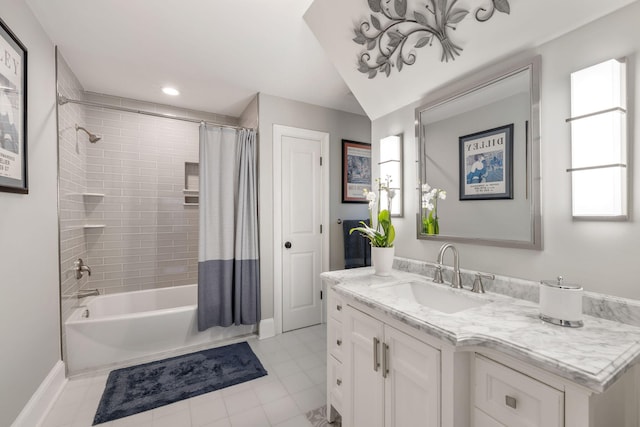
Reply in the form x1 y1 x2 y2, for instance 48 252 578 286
26 0 634 119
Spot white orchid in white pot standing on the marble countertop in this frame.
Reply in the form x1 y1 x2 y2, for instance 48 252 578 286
349 176 396 276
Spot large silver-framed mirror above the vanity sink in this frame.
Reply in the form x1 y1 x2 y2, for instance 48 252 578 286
416 56 542 250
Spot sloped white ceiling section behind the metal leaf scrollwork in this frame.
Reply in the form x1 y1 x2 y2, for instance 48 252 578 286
305 0 634 119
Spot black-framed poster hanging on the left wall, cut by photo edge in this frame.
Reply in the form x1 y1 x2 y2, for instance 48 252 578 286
0 20 29 194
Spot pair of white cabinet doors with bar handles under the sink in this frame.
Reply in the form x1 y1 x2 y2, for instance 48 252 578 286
342 305 440 427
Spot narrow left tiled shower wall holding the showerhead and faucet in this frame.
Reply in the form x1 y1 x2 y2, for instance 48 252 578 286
57 51 88 364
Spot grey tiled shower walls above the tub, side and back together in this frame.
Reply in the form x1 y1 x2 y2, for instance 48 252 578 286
58 56 238 300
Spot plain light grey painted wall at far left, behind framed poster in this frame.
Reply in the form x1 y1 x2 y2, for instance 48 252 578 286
0 0 60 426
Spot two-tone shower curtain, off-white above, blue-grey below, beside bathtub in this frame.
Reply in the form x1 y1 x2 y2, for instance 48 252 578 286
198 124 260 331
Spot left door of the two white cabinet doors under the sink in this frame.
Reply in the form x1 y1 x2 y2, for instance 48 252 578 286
342 306 384 427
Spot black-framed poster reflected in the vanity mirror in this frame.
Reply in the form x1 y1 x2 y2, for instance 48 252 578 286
459 123 513 200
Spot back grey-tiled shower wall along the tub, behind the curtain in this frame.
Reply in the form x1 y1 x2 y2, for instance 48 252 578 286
85 93 237 293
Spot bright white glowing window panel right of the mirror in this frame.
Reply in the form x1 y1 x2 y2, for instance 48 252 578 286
567 59 627 219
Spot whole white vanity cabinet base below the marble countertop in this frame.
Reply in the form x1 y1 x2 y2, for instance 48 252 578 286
327 280 640 427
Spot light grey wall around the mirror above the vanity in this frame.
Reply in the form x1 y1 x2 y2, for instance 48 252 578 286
372 2 640 299
